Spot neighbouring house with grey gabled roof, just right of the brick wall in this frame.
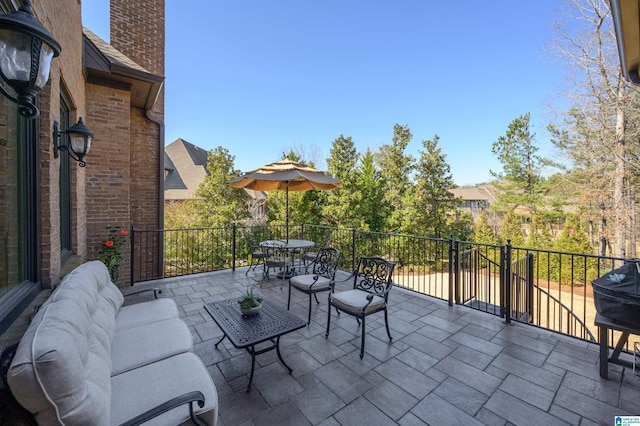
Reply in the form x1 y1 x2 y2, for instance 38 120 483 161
164 139 207 201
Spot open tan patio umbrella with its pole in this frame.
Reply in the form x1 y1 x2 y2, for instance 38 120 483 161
227 160 342 241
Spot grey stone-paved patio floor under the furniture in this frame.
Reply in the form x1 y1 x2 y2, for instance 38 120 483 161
125 268 640 426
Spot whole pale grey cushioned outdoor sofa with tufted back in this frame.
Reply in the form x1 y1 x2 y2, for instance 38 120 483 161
2 261 218 426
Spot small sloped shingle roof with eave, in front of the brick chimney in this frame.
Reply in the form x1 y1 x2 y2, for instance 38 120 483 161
82 28 164 109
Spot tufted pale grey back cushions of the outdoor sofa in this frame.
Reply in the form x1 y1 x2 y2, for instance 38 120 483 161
8 261 123 425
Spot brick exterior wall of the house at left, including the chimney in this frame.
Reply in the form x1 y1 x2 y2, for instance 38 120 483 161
0 0 164 340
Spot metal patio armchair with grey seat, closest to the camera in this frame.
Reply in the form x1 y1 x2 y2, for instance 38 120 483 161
325 257 395 359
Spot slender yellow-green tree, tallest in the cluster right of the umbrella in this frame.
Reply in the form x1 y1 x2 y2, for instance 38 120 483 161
376 124 415 232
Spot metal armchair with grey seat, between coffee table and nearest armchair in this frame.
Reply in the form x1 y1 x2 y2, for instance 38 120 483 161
287 247 342 325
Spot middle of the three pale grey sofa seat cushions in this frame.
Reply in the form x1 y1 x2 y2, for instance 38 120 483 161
111 318 193 376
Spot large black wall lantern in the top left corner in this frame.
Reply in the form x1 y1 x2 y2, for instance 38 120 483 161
0 0 61 118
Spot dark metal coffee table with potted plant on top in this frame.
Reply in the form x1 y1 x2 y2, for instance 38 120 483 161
204 293 307 392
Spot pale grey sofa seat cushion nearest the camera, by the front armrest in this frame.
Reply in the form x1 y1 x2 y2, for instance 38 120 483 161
111 352 218 426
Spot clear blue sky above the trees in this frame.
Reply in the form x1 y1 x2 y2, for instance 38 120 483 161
82 0 564 185
